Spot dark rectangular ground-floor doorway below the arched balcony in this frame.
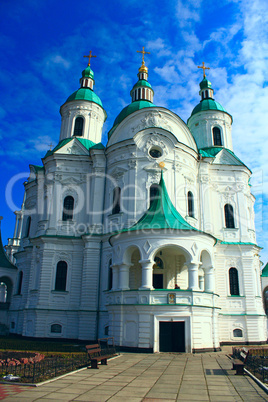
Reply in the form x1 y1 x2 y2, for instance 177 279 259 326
159 321 185 352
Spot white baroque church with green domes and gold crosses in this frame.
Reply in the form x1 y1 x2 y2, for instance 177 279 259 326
0 48 267 352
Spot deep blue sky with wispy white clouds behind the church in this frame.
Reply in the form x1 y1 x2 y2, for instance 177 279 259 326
0 0 268 263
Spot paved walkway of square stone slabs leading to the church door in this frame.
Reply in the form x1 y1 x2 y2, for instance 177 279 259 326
0 352 268 402
